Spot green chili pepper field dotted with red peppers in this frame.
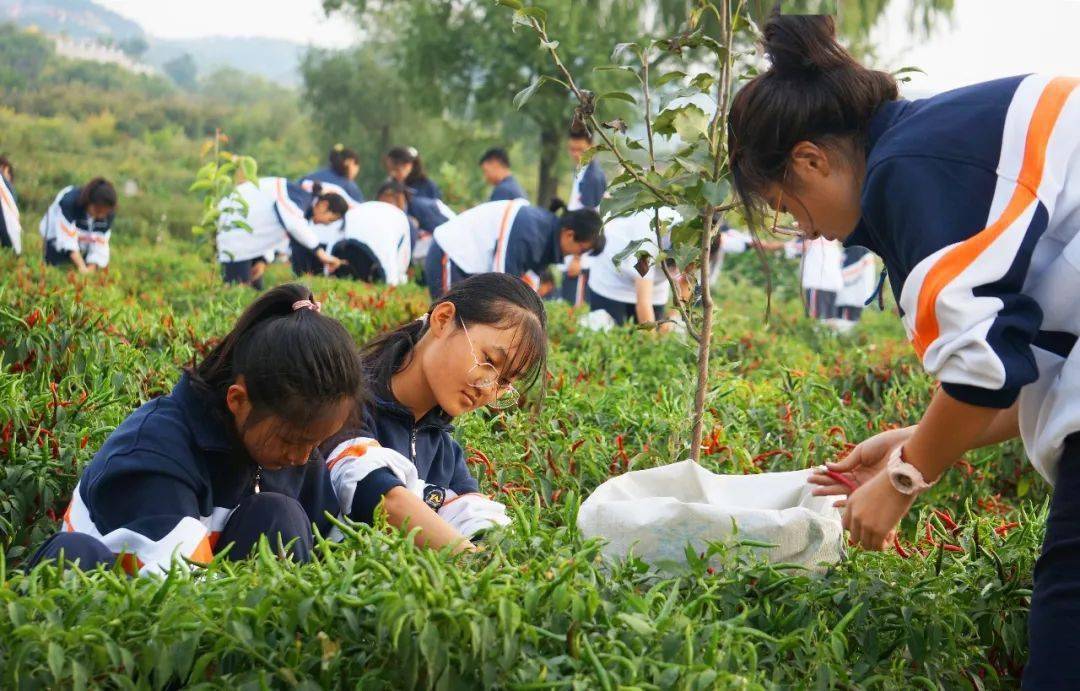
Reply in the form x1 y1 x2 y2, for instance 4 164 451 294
0 238 1047 689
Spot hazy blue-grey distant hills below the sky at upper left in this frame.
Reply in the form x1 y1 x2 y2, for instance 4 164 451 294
0 0 306 86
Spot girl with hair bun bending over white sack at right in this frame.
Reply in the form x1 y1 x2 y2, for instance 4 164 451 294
728 16 1080 689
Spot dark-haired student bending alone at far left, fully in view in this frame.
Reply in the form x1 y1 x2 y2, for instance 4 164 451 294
39 177 117 273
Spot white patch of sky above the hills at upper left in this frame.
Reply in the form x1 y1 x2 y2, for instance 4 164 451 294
95 0 356 48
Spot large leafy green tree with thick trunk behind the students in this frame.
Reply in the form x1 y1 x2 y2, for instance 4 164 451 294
315 0 650 203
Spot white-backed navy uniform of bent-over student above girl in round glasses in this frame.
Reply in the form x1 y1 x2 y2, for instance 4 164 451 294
424 200 563 297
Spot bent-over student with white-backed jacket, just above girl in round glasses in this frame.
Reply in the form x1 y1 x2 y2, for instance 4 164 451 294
423 199 604 298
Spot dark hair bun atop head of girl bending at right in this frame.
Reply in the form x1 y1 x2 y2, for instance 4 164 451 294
762 14 854 77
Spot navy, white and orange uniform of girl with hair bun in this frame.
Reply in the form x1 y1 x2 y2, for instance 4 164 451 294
847 76 1080 689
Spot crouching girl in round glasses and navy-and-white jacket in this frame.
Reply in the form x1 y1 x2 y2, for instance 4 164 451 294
322 273 548 550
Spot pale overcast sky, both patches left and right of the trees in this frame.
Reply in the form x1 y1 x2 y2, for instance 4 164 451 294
98 0 1080 95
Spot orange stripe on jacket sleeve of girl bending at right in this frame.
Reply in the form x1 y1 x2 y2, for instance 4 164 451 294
913 77 1080 358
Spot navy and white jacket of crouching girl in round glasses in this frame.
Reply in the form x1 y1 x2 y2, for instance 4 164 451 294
322 352 510 538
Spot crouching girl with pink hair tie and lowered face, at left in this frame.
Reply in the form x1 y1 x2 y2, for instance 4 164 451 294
31 284 364 573
